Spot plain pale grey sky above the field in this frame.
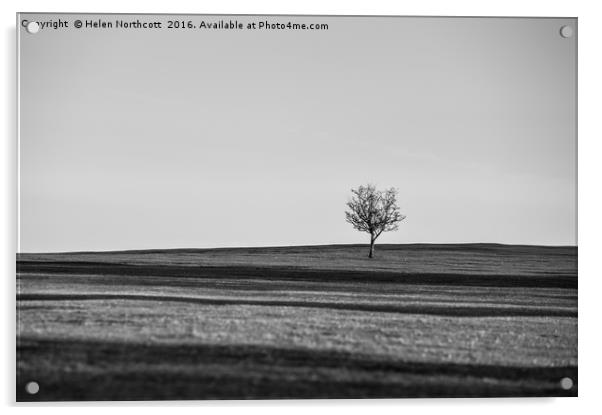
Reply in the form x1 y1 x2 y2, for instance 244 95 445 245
20 15 577 252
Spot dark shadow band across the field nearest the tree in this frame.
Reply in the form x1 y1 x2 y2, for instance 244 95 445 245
17 261 577 288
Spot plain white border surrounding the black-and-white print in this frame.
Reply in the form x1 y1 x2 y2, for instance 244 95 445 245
0 0 602 415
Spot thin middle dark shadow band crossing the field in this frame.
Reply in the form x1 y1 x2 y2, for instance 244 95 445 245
17 293 577 317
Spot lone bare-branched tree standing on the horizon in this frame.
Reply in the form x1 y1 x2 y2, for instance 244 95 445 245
345 184 406 258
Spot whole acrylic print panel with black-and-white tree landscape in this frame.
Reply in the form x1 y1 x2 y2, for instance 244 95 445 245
16 13 578 401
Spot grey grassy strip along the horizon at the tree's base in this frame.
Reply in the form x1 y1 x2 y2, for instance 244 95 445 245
18 244 577 276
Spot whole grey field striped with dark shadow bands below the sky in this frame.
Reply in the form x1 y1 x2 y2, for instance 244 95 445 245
17 244 578 401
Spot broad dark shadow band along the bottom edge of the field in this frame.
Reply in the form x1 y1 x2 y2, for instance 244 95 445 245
17 338 578 401
